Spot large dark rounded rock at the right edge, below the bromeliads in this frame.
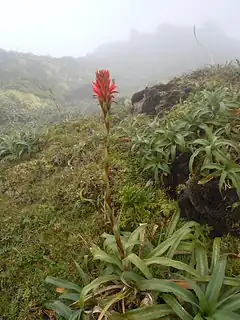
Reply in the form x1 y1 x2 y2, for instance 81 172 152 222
179 179 240 237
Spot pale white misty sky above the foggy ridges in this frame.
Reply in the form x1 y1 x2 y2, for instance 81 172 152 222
0 0 240 56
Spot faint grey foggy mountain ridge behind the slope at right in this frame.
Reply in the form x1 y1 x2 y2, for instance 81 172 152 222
91 24 240 91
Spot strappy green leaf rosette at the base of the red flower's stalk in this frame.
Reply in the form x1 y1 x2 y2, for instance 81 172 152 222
46 211 206 320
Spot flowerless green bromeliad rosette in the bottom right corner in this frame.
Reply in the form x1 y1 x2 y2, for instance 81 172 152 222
129 238 240 320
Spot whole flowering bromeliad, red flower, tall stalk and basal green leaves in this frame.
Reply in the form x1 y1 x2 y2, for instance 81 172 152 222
46 70 206 320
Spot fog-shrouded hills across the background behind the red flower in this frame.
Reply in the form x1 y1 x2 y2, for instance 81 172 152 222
0 25 240 130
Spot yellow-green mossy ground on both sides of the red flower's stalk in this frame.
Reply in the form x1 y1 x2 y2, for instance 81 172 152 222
0 63 240 320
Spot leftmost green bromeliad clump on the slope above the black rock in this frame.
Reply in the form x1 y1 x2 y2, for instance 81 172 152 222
132 120 192 184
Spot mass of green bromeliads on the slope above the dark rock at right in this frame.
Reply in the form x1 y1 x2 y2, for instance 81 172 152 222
129 66 240 201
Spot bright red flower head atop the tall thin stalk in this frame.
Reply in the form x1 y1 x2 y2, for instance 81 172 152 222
93 70 117 108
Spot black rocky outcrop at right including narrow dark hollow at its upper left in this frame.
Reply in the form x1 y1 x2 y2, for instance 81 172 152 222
165 154 240 237
